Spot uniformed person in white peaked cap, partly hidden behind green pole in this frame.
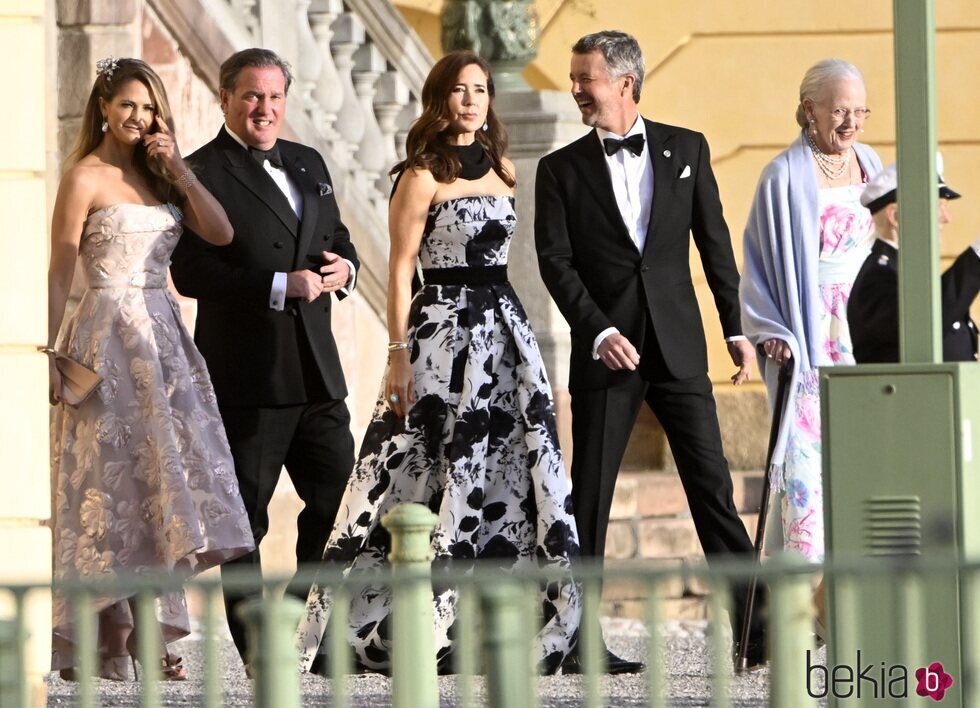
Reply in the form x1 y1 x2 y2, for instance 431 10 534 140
847 156 980 364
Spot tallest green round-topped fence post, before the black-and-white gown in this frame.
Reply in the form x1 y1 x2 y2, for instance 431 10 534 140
381 504 439 708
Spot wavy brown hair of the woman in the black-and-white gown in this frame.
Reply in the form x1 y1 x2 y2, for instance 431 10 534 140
389 50 516 187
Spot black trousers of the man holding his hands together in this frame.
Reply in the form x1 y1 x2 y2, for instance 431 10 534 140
221 400 354 662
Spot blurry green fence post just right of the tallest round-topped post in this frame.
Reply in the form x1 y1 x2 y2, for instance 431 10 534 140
482 582 534 708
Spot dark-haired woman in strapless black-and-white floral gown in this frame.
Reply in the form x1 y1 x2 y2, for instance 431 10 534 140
298 51 581 673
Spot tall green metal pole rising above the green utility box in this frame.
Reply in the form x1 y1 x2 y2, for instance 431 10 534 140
894 0 943 364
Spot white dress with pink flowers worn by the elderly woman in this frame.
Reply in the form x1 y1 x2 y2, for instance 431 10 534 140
781 184 873 562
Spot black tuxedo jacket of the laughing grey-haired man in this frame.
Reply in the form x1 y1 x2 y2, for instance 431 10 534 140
534 120 741 388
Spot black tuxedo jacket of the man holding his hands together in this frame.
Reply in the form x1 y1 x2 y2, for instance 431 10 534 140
171 128 358 407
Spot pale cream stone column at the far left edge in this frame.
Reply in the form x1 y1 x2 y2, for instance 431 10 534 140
0 0 52 705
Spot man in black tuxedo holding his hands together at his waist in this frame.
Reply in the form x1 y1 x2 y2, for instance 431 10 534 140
171 49 358 669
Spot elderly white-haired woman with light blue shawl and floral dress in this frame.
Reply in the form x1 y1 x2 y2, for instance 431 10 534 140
740 59 881 563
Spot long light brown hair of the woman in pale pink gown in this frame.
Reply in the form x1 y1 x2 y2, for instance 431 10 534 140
63 58 184 202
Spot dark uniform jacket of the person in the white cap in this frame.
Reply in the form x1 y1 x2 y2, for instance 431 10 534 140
847 239 980 364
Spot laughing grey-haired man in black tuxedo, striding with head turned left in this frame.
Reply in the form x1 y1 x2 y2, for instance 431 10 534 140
534 32 763 672
